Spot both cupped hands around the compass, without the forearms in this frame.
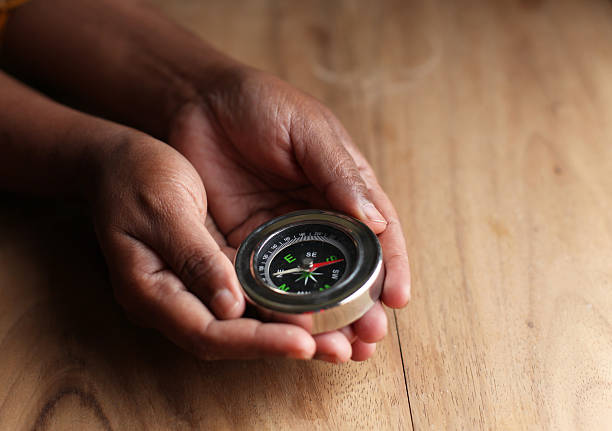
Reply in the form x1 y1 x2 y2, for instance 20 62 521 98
91 67 410 362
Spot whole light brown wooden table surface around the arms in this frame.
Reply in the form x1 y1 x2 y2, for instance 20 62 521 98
0 0 612 430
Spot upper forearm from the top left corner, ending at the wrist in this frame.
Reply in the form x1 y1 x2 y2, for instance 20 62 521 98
2 0 244 139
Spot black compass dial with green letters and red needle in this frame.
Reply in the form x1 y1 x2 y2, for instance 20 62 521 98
254 224 356 295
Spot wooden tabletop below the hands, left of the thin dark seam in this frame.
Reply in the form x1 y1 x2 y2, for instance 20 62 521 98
0 201 410 430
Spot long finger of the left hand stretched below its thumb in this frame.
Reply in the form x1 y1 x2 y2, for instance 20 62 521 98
105 233 316 359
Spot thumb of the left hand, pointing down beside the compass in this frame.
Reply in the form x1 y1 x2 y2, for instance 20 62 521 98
143 206 244 319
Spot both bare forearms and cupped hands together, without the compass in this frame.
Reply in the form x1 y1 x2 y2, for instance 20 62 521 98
0 0 410 362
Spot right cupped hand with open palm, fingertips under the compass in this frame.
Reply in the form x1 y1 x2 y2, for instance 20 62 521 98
169 67 410 362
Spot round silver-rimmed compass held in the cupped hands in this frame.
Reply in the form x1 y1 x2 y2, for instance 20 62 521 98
234 210 384 334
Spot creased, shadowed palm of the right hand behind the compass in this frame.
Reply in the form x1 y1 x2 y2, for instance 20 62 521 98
171 92 329 248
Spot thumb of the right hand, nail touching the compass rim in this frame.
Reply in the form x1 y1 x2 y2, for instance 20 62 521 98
290 108 386 233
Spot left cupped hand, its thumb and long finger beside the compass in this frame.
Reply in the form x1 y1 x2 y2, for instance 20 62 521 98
90 132 316 359
